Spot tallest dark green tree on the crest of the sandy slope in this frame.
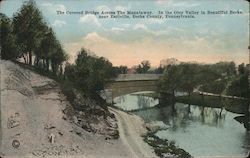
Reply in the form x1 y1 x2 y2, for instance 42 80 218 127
13 0 46 65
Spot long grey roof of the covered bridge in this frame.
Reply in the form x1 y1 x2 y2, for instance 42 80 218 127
113 74 162 81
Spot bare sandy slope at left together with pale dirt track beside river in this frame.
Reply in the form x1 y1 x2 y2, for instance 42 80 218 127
0 60 154 158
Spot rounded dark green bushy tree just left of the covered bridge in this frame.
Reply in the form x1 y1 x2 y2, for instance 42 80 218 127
64 48 114 94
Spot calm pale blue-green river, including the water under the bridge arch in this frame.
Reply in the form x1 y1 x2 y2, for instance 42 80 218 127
113 92 250 157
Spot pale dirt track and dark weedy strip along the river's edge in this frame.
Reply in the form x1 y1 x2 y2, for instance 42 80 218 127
109 108 192 158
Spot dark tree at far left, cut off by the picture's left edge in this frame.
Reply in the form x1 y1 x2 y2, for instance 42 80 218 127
0 13 19 60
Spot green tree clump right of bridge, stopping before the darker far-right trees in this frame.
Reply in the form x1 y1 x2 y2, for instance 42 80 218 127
159 62 236 95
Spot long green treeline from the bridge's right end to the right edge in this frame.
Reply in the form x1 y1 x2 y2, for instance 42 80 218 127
158 62 249 98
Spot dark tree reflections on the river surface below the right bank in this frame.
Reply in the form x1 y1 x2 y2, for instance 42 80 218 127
134 103 227 128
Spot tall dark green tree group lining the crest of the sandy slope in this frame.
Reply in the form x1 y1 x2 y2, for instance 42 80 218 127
5 0 68 75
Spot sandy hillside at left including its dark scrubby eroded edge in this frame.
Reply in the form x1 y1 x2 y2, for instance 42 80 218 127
0 60 153 157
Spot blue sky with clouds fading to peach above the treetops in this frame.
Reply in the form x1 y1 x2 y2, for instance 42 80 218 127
1 0 249 67
